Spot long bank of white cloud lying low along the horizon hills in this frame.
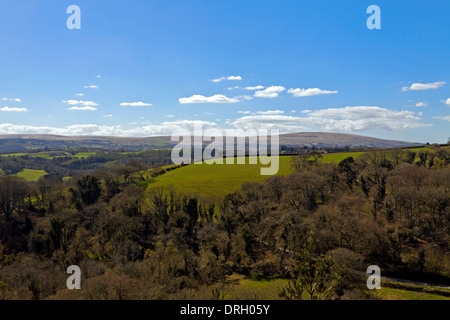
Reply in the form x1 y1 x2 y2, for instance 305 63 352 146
0 106 428 137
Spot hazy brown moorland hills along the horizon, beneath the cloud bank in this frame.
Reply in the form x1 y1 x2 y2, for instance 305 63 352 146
0 132 420 153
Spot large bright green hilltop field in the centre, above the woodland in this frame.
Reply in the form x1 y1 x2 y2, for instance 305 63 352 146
148 152 363 197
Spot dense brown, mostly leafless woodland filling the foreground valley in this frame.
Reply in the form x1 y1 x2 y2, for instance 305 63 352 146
0 148 450 299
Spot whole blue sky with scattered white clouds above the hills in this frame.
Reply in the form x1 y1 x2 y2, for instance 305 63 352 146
0 0 450 143
